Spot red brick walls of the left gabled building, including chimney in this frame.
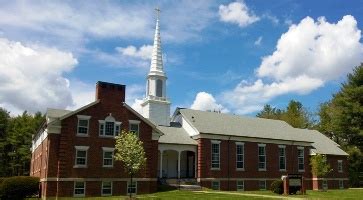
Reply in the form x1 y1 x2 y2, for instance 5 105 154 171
32 83 158 196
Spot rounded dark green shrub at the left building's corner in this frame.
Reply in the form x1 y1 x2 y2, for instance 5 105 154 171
0 176 39 200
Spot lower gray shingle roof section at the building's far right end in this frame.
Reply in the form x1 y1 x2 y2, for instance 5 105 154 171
296 129 348 156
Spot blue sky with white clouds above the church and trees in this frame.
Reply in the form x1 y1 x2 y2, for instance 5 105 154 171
0 0 363 115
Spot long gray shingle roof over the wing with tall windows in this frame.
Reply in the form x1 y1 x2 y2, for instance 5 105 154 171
180 109 310 142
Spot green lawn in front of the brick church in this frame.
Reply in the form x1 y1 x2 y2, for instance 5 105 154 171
32 189 363 200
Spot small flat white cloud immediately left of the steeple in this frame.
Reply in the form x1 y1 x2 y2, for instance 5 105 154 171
116 45 153 61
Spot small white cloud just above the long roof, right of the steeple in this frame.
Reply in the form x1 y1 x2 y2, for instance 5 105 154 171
190 92 229 113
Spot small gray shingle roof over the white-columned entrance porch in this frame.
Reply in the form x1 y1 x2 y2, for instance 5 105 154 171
157 126 198 145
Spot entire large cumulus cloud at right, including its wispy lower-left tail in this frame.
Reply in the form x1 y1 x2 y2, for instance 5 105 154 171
220 15 363 114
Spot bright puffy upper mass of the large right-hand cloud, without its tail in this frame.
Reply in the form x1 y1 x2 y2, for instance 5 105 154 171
257 15 363 81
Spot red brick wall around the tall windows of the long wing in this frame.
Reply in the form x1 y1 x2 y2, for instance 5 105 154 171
198 138 310 178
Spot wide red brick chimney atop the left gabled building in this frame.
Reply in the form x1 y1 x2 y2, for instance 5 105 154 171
96 81 126 104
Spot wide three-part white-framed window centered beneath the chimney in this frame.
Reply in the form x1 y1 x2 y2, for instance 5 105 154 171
98 115 121 137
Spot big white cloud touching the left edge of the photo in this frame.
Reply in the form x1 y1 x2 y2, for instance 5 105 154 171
0 38 77 112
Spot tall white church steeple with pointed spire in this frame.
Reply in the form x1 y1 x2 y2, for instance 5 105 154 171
141 8 170 126
